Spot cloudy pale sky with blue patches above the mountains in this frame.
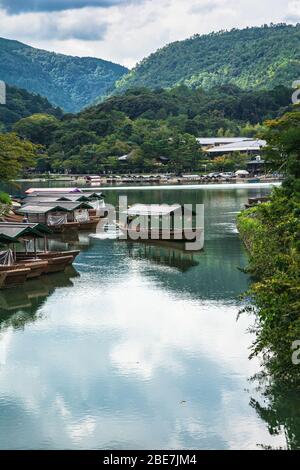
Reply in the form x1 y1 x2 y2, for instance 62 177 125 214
0 0 300 68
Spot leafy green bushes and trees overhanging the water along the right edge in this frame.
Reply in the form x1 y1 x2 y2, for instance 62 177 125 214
237 106 300 450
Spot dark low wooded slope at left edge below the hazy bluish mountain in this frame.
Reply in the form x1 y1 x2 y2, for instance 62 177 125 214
0 85 63 132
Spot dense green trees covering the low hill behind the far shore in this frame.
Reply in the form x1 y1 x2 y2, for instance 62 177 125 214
13 85 291 173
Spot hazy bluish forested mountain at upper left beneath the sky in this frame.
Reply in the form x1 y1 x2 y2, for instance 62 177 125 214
0 38 127 112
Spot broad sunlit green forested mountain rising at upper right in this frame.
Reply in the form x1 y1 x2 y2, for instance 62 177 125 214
116 24 300 90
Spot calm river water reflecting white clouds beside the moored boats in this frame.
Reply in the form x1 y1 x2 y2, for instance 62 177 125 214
0 183 292 449
